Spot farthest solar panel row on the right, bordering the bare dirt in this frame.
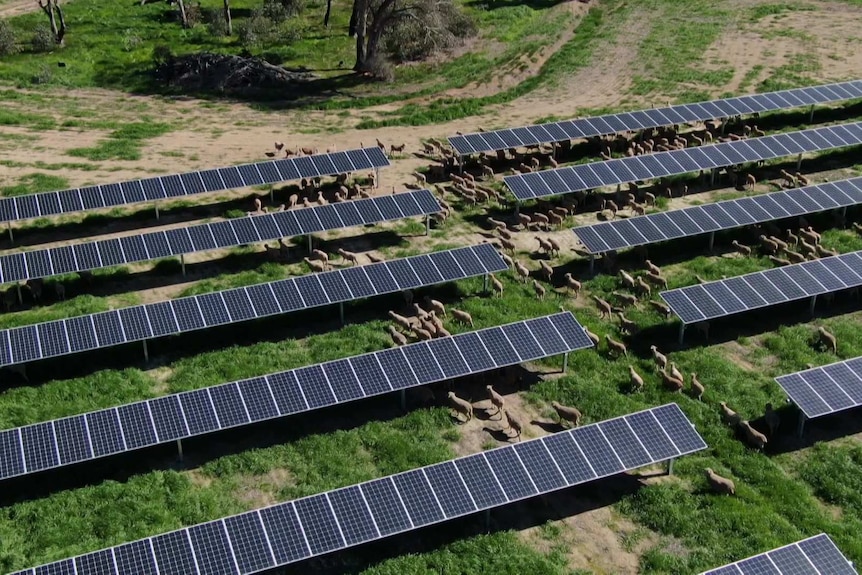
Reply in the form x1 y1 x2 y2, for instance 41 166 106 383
449 80 862 155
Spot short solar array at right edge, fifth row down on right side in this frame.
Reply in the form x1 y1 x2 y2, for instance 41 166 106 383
775 357 862 418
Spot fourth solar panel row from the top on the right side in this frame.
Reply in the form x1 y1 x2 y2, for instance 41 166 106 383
661 252 862 324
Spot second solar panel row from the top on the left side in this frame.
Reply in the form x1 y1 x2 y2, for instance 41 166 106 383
0 190 442 283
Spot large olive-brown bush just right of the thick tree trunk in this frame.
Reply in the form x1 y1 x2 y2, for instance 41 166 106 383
383 0 476 62
